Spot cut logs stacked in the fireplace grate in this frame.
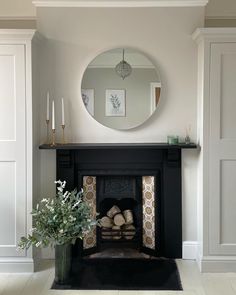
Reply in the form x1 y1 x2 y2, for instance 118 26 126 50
100 205 135 240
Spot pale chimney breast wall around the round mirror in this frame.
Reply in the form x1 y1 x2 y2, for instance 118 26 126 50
35 8 204 254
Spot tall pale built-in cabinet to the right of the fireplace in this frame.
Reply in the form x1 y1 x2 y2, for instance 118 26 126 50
193 28 236 271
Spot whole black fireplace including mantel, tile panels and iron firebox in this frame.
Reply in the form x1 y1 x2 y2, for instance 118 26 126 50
40 144 196 258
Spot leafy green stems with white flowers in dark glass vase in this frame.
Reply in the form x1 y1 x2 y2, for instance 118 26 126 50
18 180 97 284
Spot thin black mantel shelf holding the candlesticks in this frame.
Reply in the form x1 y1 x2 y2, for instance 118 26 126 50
39 143 199 150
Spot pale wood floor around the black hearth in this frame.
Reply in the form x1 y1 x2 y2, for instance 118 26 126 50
0 260 236 295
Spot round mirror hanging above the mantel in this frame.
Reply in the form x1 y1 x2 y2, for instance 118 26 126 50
81 48 161 130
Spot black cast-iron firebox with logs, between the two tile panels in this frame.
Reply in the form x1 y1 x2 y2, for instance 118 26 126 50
97 175 142 250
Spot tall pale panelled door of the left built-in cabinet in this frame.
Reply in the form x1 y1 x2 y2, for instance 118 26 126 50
0 45 27 257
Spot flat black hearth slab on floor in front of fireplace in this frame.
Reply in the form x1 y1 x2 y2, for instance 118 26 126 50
52 258 183 291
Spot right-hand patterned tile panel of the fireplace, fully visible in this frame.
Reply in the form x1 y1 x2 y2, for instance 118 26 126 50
142 176 155 249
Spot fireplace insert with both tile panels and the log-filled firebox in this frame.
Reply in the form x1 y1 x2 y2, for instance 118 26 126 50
83 175 158 256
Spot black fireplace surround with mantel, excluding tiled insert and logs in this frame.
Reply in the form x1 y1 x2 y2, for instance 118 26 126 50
40 143 196 258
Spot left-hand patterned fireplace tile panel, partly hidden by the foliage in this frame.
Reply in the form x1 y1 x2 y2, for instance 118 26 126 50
83 176 97 249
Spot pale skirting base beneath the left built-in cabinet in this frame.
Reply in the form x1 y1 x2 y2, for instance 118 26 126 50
0 258 34 273
